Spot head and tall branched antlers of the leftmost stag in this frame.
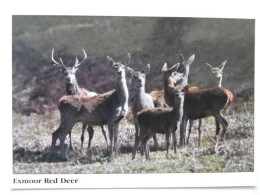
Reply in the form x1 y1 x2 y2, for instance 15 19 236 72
51 48 87 85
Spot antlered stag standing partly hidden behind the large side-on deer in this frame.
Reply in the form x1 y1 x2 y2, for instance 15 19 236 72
51 48 108 149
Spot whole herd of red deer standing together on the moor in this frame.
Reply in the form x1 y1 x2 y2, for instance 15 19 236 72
50 49 233 160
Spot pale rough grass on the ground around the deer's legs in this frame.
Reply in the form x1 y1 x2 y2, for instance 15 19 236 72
13 100 254 174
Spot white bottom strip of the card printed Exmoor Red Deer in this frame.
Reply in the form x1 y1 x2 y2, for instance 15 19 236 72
12 172 257 189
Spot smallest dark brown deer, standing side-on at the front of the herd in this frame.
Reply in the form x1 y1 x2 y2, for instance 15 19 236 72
132 88 184 160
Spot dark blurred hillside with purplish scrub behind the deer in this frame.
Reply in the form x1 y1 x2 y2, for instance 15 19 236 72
12 16 255 115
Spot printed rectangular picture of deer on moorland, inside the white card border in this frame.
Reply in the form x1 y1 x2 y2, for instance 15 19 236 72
12 15 255 175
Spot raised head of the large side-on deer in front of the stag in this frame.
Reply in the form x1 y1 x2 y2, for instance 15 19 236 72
107 53 132 78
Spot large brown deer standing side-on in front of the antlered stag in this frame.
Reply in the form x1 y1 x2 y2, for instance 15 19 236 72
51 54 130 160
